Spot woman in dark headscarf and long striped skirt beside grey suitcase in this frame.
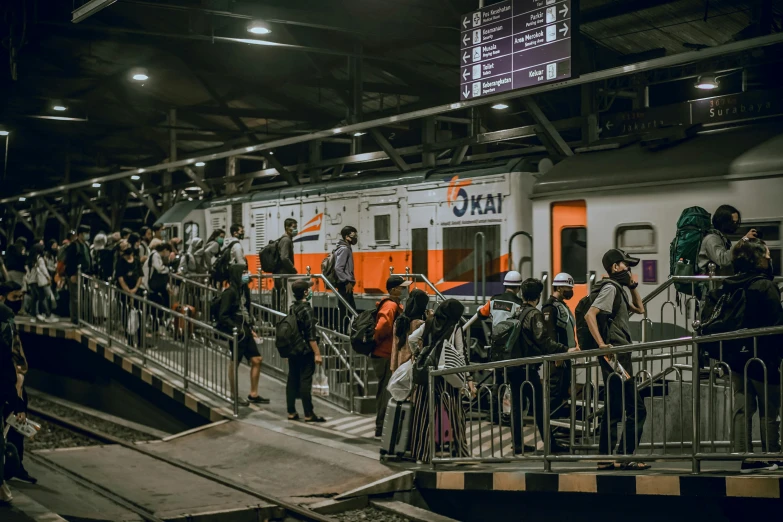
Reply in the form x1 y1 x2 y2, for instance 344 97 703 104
408 299 474 462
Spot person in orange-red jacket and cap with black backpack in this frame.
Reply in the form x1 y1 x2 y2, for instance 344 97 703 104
370 275 411 437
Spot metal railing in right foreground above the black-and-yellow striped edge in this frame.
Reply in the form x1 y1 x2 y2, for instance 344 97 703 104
427 327 783 473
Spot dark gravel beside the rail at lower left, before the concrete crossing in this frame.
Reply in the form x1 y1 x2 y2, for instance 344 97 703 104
25 396 153 450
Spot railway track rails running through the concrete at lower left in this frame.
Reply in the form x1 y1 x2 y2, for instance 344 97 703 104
28 406 338 522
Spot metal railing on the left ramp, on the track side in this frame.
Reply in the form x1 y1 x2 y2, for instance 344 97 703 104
77 272 239 416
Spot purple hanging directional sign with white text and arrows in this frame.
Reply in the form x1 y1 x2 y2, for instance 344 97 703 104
459 0 578 100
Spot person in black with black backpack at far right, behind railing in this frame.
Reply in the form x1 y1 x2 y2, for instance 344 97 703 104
707 237 783 473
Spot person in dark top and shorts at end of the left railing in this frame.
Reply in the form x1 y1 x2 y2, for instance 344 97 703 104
218 264 269 406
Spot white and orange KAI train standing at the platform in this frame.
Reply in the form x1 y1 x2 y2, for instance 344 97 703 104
158 121 783 328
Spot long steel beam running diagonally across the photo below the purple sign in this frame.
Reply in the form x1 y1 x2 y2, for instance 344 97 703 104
0 33 783 203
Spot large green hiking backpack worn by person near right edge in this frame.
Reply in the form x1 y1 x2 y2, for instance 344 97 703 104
669 207 712 296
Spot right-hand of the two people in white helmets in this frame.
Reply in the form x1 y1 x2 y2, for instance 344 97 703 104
541 272 576 416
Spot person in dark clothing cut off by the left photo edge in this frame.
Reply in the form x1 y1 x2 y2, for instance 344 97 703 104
0 281 26 502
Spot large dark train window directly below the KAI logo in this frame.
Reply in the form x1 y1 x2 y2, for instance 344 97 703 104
443 225 501 283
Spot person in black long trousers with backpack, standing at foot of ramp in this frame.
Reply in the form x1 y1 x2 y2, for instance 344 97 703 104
285 279 326 422
